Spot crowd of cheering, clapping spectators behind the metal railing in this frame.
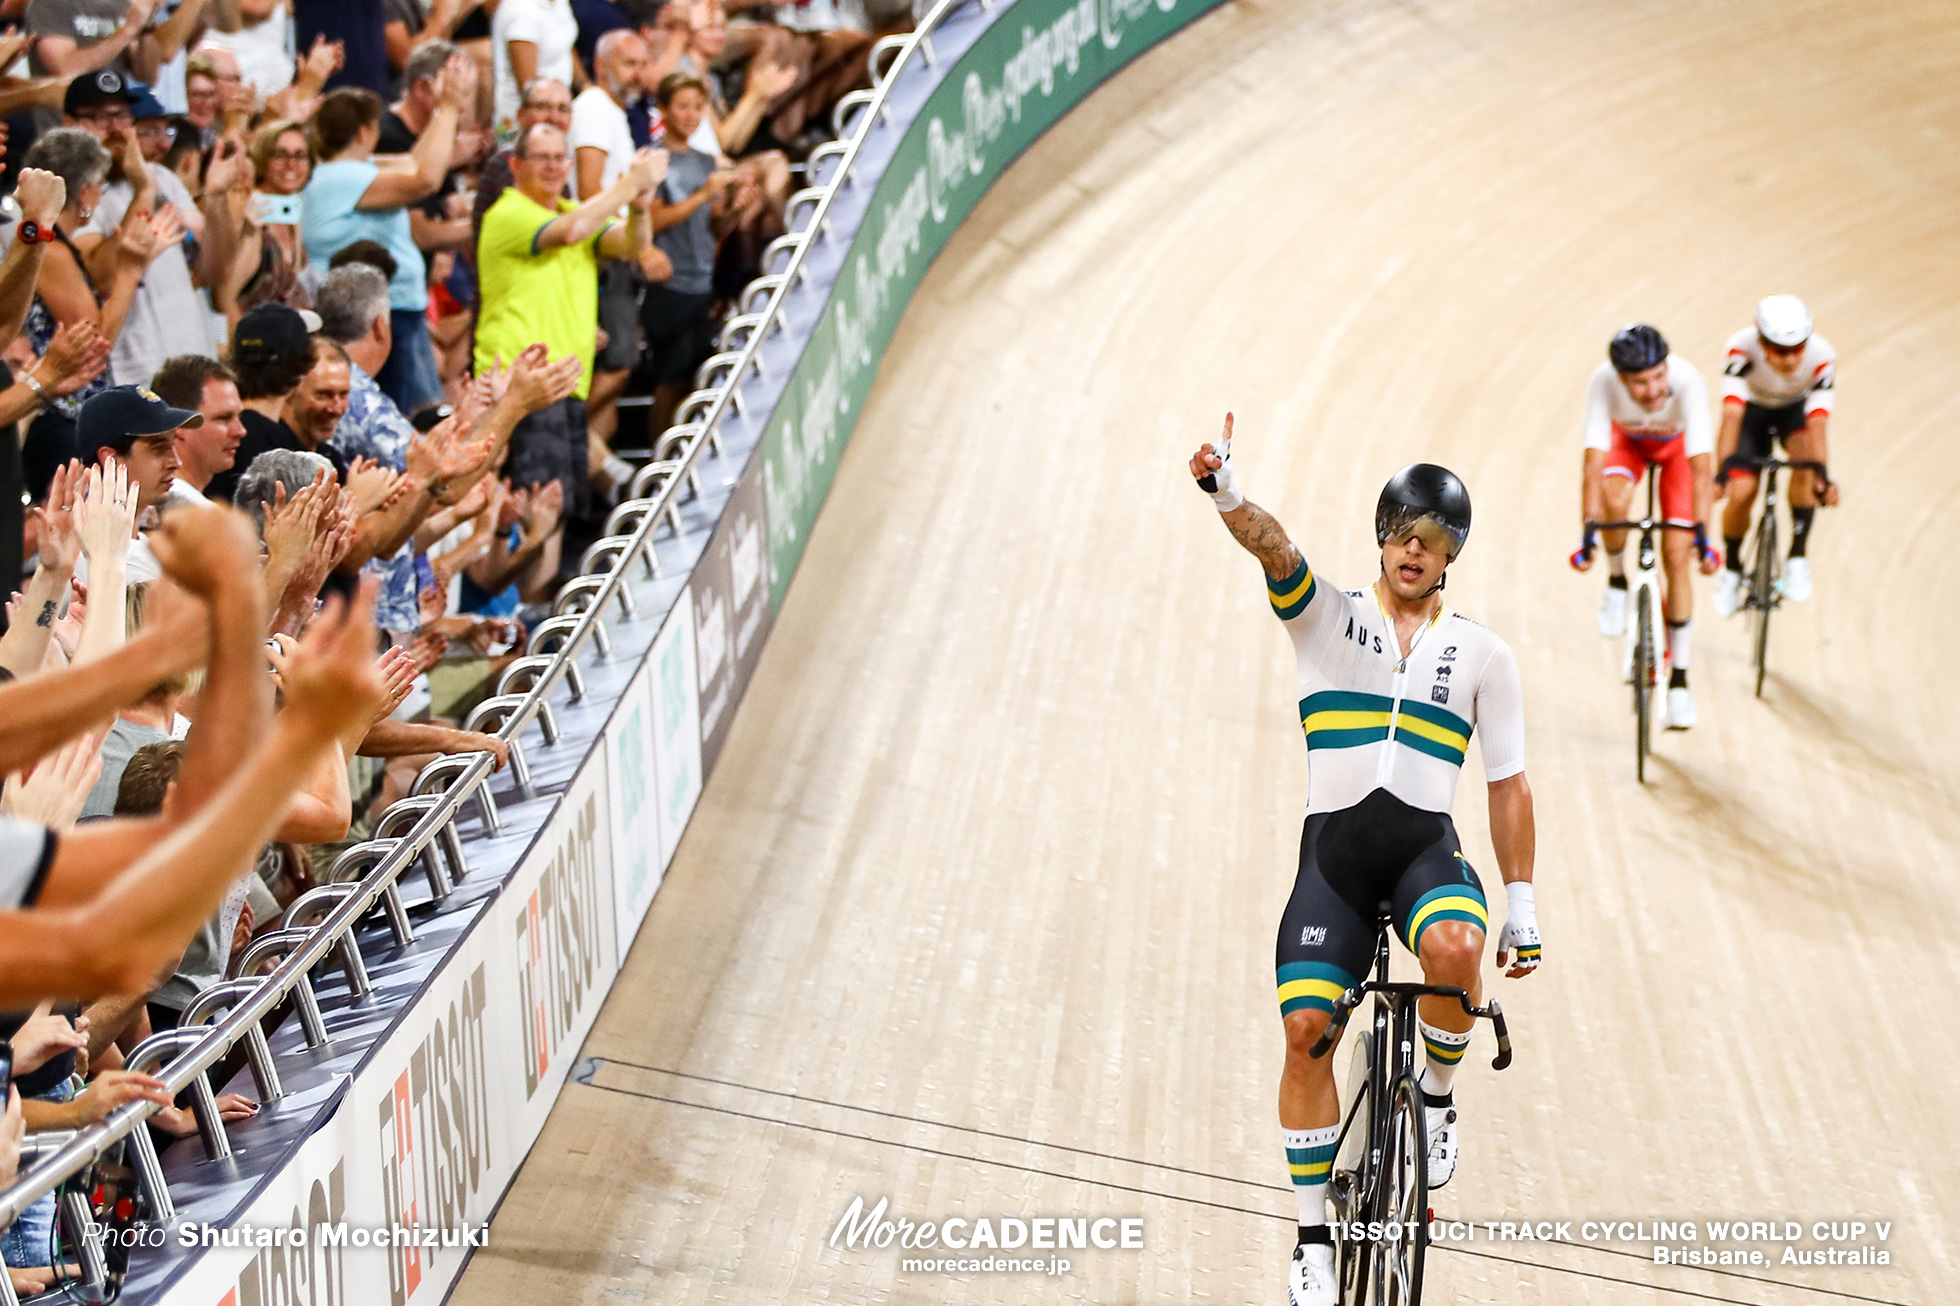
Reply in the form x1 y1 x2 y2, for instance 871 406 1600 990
0 0 909 1294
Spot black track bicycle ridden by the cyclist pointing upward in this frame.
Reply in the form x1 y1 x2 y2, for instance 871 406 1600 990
1307 902 1511 1306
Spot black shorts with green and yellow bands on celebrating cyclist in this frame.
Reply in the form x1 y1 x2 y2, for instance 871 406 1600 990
1278 788 1490 1016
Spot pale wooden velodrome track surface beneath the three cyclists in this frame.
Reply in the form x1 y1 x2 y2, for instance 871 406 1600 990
455 0 1960 1306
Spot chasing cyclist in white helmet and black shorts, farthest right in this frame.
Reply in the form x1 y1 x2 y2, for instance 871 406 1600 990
1715 294 1837 618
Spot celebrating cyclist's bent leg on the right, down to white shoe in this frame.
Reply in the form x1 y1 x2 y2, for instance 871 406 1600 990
1396 818 1490 1188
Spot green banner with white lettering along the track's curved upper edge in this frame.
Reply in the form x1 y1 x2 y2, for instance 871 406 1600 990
762 0 1223 612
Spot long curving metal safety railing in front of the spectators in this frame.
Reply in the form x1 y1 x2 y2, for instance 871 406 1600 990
0 0 1000 1306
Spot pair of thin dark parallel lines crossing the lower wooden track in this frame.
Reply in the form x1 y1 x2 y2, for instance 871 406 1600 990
576 1057 1909 1306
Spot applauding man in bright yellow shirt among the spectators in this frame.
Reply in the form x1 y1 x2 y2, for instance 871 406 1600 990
476 124 666 569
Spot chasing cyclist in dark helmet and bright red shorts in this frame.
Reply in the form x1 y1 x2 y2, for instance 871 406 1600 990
1572 324 1721 729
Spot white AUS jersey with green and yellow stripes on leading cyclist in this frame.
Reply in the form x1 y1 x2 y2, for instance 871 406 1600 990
1266 563 1525 816
